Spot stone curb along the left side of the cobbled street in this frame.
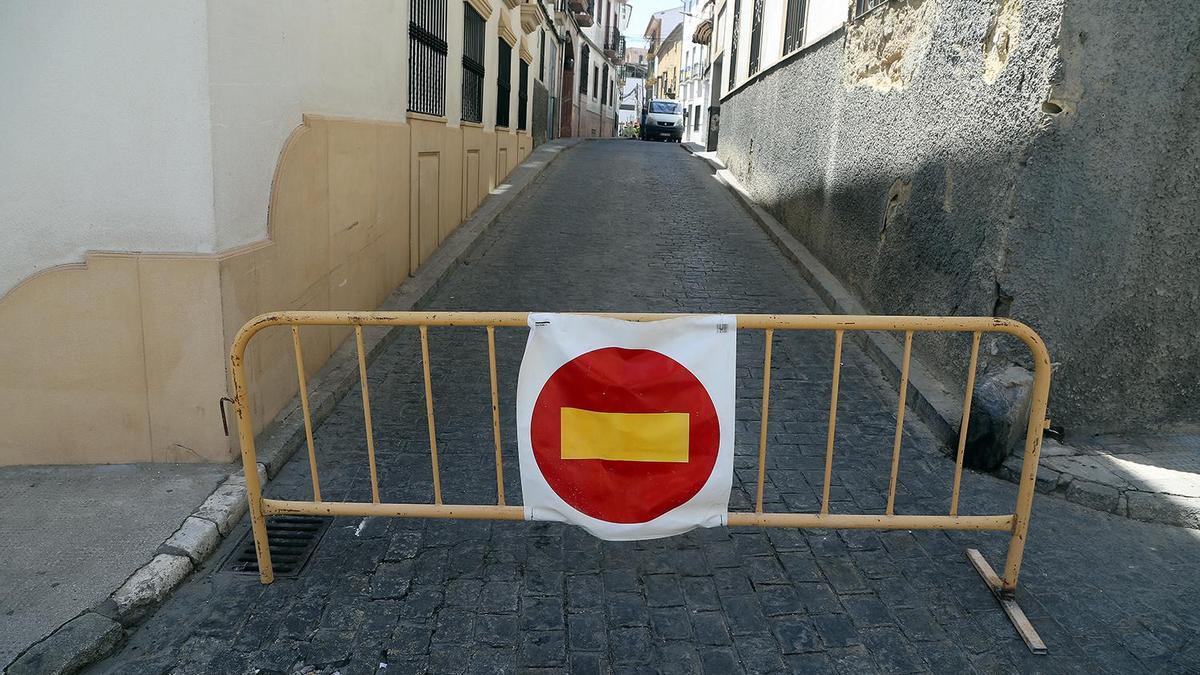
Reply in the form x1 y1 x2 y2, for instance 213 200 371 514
4 138 584 675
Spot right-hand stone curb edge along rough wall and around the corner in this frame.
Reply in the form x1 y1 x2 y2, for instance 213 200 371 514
683 144 1200 530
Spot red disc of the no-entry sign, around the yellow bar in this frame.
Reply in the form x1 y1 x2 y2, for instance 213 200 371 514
529 347 721 524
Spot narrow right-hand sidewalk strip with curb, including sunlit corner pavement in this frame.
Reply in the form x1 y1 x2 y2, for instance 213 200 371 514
682 143 1200 530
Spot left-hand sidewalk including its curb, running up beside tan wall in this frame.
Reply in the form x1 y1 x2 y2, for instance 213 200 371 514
0 138 581 674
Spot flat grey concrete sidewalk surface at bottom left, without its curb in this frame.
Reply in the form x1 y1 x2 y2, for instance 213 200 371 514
0 464 235 667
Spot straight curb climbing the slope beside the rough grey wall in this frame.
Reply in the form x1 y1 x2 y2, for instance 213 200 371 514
682 144 962 455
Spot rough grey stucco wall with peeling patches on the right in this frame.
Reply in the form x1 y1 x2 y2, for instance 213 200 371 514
719 0 1200 434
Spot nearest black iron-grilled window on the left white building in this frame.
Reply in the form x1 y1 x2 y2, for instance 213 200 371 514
408 0 446 117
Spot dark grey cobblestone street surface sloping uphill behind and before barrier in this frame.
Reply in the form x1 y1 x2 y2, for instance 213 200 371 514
94 141 1200 675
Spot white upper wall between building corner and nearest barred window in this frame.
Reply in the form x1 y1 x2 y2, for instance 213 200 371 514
205 0 408 250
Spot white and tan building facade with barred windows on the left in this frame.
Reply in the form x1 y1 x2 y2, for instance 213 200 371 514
0 0 571 464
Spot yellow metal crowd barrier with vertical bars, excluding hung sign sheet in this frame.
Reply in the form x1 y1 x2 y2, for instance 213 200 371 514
229 311 1050 653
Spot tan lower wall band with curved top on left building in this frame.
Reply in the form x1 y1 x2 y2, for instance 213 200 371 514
0 115 533 465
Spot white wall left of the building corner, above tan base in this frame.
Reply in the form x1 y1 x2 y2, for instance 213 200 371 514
0 0 213 295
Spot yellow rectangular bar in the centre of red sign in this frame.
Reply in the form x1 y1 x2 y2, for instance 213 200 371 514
559 407 690 462
